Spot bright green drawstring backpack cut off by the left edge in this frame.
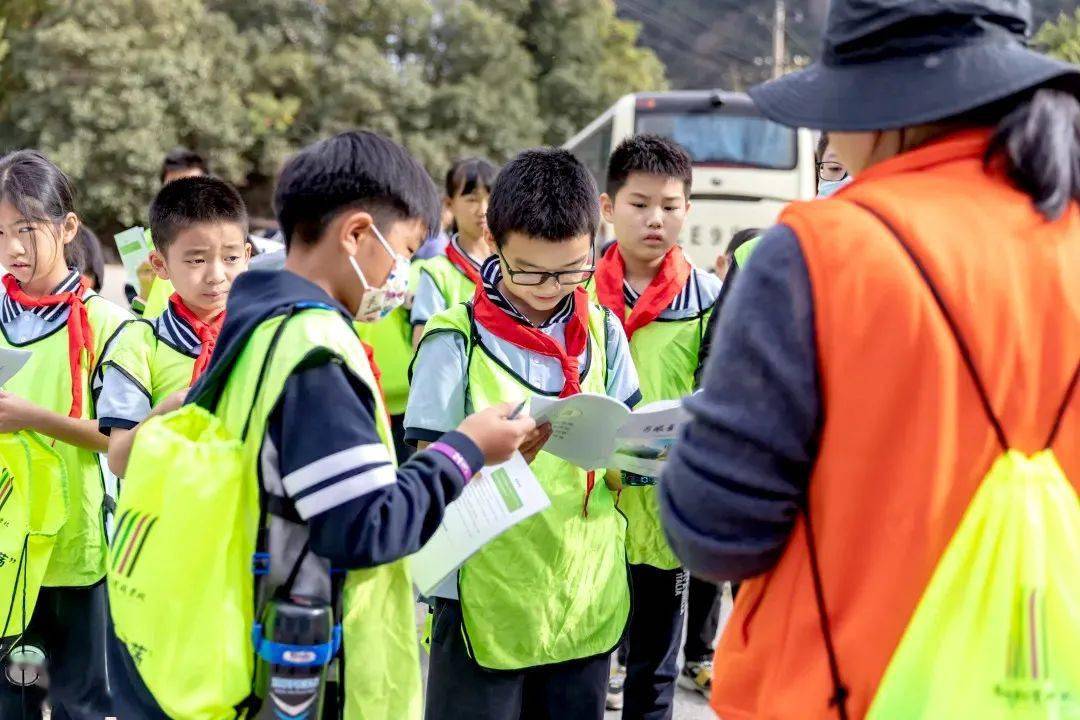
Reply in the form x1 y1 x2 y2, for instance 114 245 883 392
0 431 68 647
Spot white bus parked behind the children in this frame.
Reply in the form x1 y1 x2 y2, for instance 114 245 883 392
563 90 818 269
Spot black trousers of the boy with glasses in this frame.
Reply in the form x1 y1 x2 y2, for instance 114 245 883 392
424 598 609 720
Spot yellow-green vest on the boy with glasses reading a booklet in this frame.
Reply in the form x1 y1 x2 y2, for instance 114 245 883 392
414 303 630 670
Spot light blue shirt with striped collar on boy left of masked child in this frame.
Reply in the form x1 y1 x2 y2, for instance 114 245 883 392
95 303 209 435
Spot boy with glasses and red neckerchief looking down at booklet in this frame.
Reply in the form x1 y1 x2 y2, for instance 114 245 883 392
405 149 640 720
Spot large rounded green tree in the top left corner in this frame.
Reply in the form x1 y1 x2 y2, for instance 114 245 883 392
0 0 255 230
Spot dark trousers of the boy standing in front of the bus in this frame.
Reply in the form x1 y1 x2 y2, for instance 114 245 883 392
622 565 688 720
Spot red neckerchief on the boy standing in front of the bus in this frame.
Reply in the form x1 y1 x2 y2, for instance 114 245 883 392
596 243 692 340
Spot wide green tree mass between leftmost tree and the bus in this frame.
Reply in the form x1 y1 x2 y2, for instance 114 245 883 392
212 0 664 194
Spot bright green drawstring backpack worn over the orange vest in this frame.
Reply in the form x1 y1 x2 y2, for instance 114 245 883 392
810 205 1080 720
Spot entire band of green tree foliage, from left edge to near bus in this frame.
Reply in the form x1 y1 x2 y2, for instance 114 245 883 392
0 0 664 230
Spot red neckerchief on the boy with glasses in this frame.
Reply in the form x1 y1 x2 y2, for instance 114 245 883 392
473 283 596 517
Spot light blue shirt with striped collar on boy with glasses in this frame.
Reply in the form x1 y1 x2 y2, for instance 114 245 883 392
405 256 642 444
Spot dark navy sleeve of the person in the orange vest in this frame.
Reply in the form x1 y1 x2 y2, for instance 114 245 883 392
659 226 821 580
